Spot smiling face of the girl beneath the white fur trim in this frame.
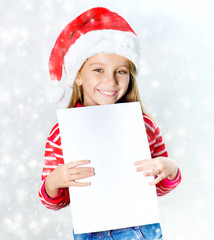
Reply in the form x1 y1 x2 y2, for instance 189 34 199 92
75 53 129 106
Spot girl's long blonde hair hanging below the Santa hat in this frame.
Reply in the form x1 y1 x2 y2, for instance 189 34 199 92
68 61 148 115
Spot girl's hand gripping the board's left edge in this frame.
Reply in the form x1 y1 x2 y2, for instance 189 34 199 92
45 160 95 197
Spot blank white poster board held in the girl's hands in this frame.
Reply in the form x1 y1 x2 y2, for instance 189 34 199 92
57 102 159 234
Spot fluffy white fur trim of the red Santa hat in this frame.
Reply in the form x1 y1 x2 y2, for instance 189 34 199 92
64 30 140 87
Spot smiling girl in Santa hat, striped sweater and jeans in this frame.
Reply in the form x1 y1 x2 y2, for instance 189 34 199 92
39 8 181 240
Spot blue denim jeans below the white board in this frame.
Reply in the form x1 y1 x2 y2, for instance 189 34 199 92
74 223 163 240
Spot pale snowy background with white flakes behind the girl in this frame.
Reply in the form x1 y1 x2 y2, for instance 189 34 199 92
0 0 214 240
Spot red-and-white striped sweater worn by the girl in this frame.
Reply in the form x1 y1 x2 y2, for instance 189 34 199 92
39 104 181 210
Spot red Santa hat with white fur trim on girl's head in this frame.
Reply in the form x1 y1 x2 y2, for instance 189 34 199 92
49 7 140 92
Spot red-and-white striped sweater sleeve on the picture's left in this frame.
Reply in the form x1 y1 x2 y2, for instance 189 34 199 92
39 124 70 210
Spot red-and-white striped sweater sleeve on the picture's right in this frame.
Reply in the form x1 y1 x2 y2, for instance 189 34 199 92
144 115 181 196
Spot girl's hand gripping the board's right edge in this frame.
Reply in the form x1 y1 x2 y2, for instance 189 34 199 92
134 157 178 186
